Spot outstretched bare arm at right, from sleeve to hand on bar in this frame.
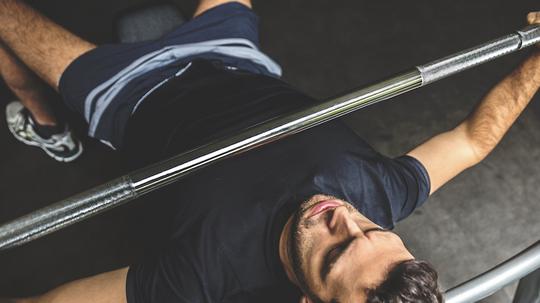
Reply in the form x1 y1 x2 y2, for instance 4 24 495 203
408 12 540 194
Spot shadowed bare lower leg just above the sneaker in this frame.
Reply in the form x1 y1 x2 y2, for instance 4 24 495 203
0 42 57 126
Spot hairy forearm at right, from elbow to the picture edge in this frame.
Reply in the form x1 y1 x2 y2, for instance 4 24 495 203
458 51 540 161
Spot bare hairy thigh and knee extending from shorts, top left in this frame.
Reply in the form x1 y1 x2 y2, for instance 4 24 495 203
0 0 95 90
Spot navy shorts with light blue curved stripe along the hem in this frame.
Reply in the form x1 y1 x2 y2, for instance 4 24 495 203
59 2 281 148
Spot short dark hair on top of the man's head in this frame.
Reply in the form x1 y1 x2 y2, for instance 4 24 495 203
367 260 443 303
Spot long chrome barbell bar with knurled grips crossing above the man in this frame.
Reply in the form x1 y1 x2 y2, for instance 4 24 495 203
0 25 540 250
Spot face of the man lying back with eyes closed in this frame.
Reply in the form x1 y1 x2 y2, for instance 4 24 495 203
280 195 414 303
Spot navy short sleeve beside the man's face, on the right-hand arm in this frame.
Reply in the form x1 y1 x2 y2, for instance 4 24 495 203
314 152 430 228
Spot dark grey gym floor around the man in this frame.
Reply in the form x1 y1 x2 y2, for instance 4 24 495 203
0 0 540 303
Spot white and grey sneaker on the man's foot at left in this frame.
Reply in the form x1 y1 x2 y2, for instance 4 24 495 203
6 101 83 162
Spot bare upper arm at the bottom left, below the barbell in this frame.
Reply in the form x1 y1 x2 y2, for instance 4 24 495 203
14 267 128 303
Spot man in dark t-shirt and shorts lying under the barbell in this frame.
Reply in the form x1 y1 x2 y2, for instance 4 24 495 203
0 0 540 303
